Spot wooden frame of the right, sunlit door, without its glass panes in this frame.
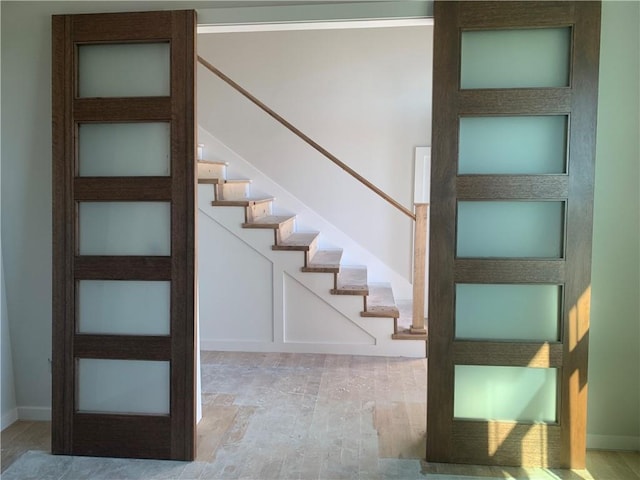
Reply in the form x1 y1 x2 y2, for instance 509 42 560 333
426 1 600 468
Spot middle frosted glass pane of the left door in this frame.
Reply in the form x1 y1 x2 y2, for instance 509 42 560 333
79 202 171 255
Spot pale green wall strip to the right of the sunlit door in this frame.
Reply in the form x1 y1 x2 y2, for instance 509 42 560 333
587 1 640 450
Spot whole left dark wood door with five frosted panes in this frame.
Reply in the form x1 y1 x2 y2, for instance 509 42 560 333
52 11 196 460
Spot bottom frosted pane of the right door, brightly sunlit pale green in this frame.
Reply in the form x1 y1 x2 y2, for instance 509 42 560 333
453 365 557 423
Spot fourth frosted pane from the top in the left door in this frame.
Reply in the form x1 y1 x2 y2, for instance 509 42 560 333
78 280 171 335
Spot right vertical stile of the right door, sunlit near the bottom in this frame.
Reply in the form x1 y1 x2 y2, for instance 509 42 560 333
559 2 601 468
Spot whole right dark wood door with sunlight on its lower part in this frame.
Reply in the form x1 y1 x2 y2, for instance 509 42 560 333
426 2 600 468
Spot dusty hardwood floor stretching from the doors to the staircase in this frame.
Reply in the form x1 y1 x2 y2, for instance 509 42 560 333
1 352 640 480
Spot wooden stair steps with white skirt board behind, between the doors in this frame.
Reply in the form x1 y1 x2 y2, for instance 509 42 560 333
198 160 427 341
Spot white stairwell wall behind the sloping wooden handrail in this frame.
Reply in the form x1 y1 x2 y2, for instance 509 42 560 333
198 26 433 279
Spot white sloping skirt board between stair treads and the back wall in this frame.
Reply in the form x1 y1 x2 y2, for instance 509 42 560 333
198 126 413 299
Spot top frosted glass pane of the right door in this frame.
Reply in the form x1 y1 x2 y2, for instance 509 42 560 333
460 28 571 88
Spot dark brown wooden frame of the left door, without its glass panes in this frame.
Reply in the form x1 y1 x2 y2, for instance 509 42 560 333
52 10 196 460
